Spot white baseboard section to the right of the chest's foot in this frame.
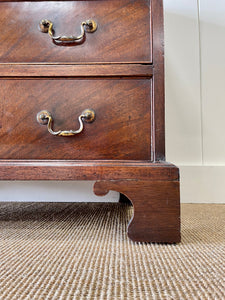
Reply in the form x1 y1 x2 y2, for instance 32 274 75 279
179 166 225 203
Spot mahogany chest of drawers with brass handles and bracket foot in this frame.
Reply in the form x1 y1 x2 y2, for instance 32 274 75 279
0 0 180 243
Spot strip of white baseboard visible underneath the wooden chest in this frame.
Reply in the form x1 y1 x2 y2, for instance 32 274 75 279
0 181 119 202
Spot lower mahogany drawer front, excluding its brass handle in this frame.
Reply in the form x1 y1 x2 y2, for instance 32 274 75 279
0 79 151 160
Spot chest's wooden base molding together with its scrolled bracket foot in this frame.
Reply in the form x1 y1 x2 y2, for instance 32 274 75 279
0 160 180 243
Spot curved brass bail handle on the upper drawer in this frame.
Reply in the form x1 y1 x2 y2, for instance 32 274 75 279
39 19 97 44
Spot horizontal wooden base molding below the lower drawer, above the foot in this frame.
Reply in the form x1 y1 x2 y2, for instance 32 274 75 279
0 160 179 181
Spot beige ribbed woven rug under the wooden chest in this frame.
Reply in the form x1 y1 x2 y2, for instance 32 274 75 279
0 203 225 300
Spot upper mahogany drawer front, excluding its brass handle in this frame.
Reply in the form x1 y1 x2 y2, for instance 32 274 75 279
0 0 152 63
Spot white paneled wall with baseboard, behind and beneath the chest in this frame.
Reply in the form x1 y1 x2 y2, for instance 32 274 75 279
0 0 225 203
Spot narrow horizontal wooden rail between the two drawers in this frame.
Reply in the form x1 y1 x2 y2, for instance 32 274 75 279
0 64 153 77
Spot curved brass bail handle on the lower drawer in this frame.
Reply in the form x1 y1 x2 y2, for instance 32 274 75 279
37 109 95 136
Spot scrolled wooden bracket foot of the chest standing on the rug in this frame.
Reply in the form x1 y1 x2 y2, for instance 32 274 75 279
94 180 180 243
